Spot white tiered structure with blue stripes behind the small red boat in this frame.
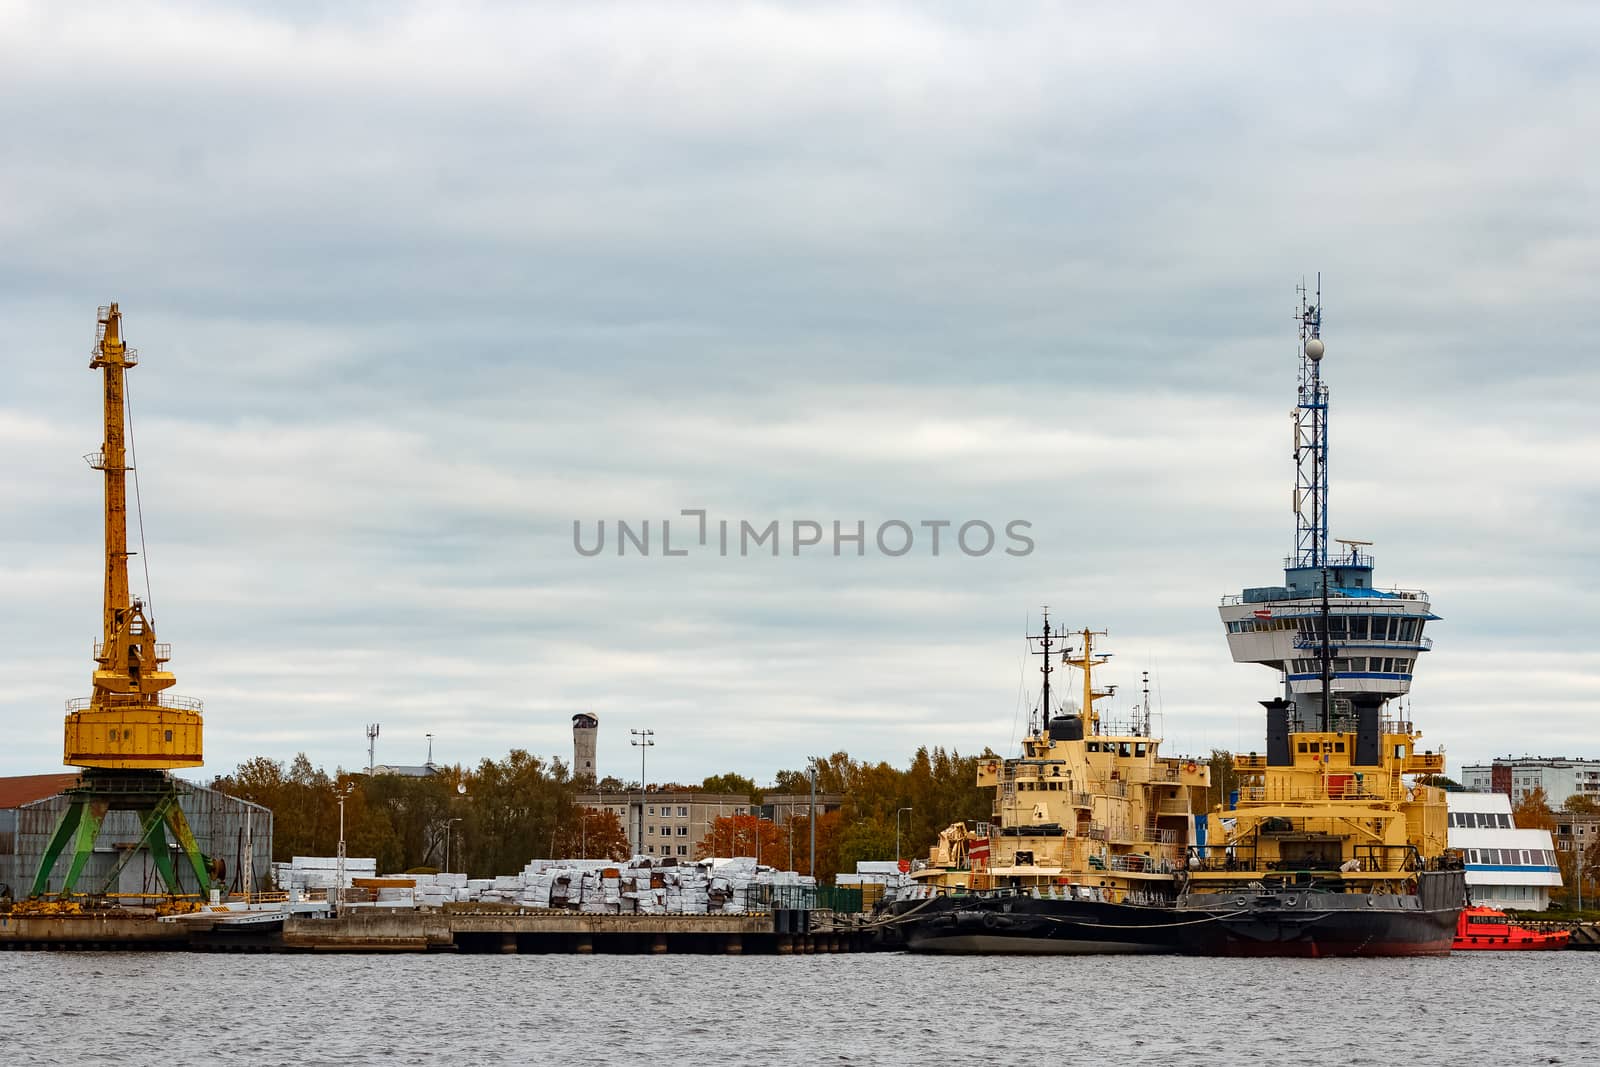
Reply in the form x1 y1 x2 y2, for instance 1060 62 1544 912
1445 793 1562 912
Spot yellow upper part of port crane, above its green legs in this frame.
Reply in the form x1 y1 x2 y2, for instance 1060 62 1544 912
62 304 205 769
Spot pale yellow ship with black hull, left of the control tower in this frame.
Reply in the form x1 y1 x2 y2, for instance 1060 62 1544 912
880 611 1211 955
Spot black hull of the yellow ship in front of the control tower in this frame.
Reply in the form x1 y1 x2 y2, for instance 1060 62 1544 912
1178 870 1466 958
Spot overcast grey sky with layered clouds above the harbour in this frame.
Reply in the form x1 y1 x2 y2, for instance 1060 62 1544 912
0 0 1600 781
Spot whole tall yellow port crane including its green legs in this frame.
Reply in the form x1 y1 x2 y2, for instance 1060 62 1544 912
34 304 210 896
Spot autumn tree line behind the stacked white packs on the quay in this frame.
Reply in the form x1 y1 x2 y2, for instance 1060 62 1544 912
213 747 995 881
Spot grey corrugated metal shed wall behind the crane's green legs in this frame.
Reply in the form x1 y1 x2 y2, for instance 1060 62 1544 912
0 785 272 896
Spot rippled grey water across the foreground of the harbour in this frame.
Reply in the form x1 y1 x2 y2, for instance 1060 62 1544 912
0 952 1600 1067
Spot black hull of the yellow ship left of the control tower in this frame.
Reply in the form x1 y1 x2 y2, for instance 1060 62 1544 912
885 896 1206 955
